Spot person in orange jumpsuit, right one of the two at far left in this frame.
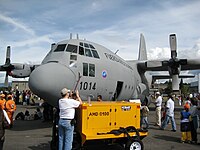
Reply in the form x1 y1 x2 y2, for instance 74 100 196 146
5 94 16 128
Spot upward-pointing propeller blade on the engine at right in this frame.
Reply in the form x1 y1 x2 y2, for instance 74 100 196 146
169 34 177 59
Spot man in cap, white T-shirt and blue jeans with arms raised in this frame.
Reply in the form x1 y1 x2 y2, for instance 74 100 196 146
58 88 82 150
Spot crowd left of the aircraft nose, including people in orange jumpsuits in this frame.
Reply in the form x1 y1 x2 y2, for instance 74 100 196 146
0 90 53 150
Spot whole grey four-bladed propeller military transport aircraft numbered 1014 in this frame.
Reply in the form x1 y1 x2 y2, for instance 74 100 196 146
0 34 200 106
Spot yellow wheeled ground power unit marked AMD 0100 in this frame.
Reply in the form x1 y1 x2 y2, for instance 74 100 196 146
73 101 148 150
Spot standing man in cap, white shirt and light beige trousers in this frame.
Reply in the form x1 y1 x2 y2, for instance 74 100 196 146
154 92 162 126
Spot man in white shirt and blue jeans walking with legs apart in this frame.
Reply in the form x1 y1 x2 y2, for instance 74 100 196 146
160 95 176 132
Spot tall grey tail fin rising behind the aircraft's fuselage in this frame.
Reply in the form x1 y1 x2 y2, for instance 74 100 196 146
138 33 147 60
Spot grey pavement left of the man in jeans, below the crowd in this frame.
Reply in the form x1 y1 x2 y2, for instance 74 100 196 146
4 105 52 150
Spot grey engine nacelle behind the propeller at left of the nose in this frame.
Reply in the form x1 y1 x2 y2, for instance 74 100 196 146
9 64 31 78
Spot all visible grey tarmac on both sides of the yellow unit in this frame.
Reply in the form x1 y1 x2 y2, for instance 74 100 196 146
4 102 200 150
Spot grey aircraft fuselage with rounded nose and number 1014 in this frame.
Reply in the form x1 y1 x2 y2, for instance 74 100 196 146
29 39 146 105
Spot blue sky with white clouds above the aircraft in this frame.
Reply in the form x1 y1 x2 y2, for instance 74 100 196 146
0 0 200 82
